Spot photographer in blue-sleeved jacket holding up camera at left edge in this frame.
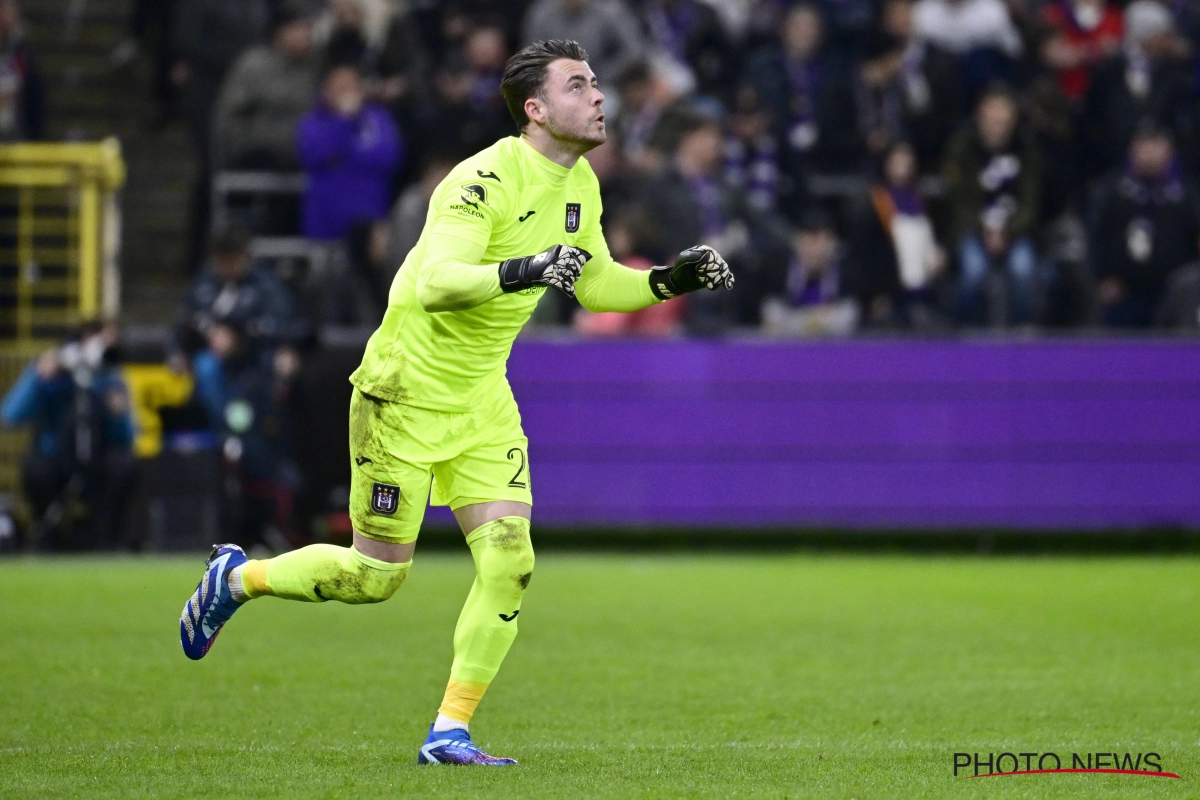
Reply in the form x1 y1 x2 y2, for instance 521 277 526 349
0 323 134 549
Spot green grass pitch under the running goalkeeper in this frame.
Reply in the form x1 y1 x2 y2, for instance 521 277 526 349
0 548 1200 798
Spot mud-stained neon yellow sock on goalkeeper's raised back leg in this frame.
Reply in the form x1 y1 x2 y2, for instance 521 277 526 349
230 545 413 604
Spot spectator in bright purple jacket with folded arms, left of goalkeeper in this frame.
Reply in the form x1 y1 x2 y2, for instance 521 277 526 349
296 65 404 240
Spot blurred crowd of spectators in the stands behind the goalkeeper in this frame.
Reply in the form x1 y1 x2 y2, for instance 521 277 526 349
124 0 1200 335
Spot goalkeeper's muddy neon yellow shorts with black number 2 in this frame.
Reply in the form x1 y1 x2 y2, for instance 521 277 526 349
350 389 533 543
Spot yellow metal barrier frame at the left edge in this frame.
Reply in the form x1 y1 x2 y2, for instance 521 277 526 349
0 139 125 347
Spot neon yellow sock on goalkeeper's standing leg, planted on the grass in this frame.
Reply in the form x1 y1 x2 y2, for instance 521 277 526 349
438 517 534 723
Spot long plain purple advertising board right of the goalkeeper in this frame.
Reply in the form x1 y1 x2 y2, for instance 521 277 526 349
489 339 1200 529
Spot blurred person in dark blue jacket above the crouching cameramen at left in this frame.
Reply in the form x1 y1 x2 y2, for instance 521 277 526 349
182 228 295 347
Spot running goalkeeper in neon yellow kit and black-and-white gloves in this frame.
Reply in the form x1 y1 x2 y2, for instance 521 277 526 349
180 40 733 765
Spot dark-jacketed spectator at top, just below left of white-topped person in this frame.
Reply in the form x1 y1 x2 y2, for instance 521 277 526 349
859 0 967 173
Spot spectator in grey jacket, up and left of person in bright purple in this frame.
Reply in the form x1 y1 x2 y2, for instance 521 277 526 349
214 8 317 170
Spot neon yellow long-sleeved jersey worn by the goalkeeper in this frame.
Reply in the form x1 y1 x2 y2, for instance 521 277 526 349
350 137 624 411
